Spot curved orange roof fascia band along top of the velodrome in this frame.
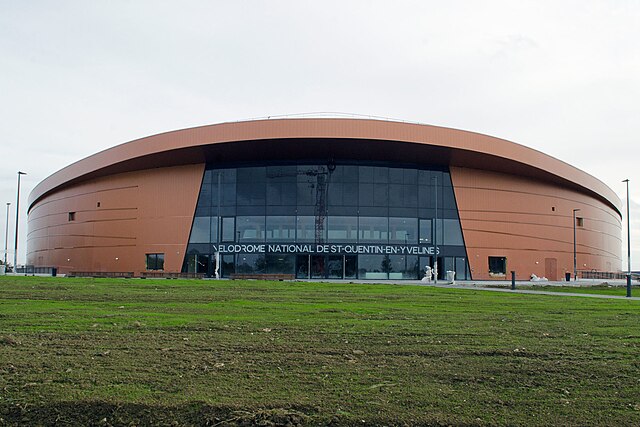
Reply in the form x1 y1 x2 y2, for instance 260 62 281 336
29 118 621 214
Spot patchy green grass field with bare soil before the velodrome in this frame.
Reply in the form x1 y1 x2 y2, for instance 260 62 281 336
0 277 640 426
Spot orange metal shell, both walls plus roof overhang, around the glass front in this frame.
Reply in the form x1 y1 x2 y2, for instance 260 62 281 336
27 118 621 279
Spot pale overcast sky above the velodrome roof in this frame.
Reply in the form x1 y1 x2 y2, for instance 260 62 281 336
0 0 640 269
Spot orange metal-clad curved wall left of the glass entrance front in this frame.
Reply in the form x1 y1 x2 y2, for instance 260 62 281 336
27 164 204 275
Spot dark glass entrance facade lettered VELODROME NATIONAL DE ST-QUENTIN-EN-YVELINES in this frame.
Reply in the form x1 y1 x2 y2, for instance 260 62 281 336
183 163 470 280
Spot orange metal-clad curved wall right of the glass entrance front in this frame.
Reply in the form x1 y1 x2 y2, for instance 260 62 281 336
451 167 621 280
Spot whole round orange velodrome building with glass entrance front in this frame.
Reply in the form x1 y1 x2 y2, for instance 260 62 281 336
27 118 621 280
